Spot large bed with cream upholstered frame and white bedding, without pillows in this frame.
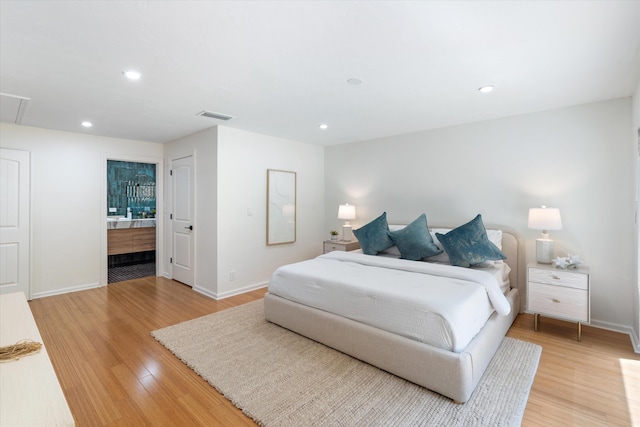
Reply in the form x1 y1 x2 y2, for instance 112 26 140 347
265 229 526 402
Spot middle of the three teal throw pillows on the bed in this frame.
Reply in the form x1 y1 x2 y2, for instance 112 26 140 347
389 214 442 261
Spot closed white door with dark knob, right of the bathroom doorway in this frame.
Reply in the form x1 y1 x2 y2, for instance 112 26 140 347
171 156 195 287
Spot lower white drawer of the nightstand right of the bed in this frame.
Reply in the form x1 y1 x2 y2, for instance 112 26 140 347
529 282 589 322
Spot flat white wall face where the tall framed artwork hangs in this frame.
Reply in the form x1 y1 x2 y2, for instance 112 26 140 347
217 126 324 297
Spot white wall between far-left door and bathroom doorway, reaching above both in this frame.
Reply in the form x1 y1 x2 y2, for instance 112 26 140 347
0 123 163 298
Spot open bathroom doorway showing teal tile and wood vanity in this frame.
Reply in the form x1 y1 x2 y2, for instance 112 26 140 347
106 160 157 283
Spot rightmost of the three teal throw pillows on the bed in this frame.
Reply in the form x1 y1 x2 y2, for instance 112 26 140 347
436 214 507 267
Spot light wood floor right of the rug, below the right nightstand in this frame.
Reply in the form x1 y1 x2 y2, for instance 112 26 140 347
507 314 640 426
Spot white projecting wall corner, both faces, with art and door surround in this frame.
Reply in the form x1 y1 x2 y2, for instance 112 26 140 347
166 126 324 298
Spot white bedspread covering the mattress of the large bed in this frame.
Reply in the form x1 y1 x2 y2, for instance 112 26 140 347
269 251 510 352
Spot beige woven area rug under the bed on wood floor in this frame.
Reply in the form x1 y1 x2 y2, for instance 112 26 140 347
151 300 541 426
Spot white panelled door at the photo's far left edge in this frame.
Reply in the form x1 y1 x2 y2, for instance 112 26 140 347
0 148 31 299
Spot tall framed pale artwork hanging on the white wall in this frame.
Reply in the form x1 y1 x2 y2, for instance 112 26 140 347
267 169 296 246
